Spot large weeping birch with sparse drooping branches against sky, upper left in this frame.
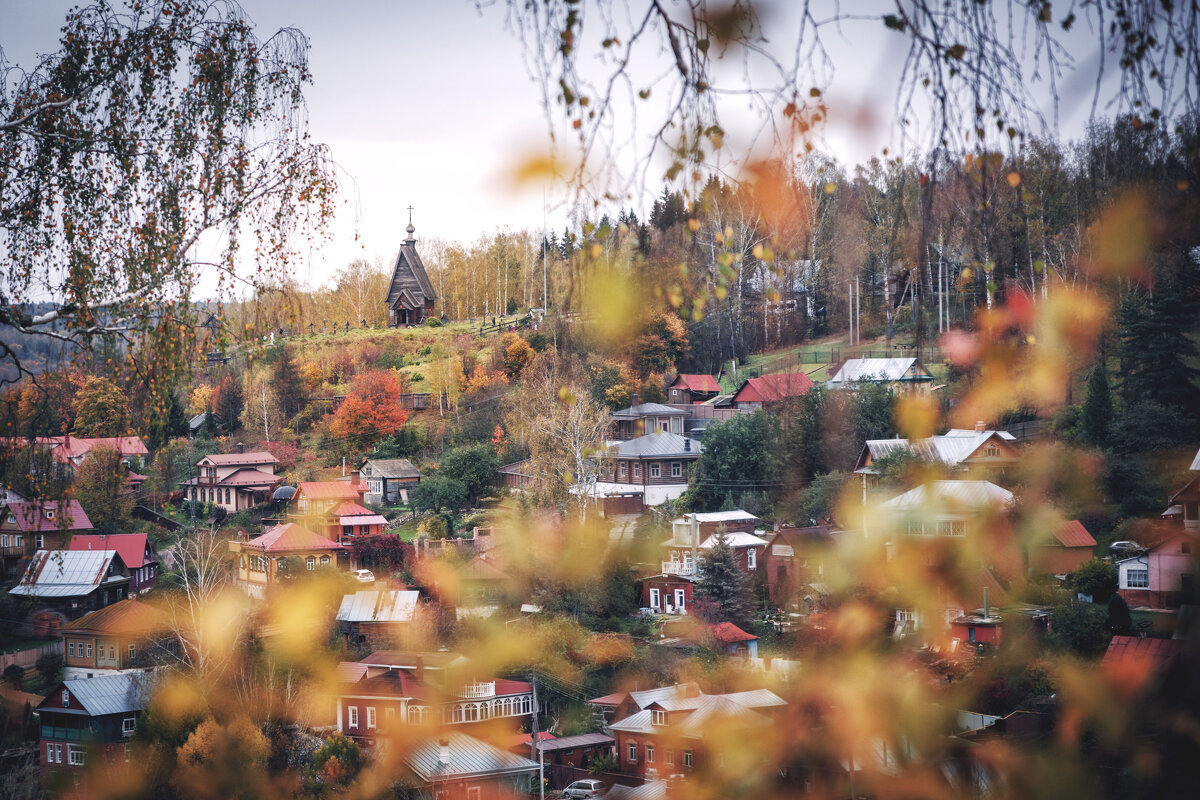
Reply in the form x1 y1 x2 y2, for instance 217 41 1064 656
0 0 336 401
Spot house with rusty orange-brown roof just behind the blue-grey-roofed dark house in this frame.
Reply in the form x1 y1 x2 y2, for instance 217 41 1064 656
62 597 169 680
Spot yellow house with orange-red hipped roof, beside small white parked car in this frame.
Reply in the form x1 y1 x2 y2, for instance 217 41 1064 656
229 522 349 600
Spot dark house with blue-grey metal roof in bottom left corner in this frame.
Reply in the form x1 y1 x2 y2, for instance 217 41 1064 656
37 673 154 798
